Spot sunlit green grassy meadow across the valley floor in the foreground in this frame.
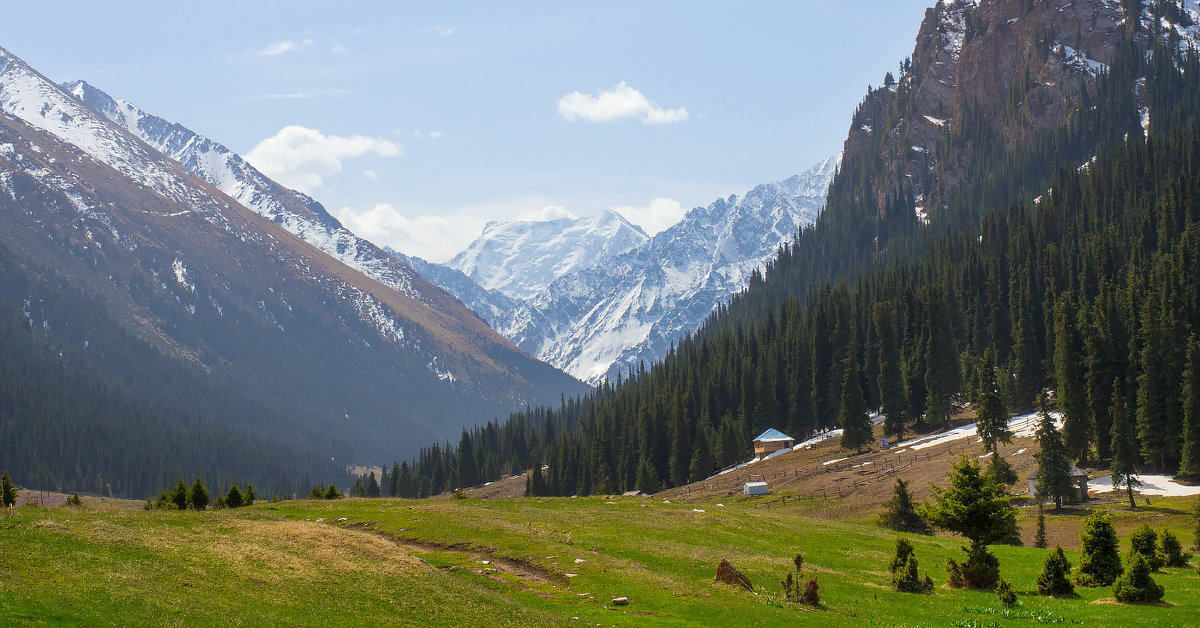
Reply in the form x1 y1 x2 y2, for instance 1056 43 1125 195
0 497 1200 627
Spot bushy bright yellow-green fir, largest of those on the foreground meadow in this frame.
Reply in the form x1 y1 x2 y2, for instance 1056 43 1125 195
918 457 1018 590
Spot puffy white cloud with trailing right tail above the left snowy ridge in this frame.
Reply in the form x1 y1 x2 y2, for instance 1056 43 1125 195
246 125 404 192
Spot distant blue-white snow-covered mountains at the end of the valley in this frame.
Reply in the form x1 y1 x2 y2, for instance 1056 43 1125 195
394 155 840 384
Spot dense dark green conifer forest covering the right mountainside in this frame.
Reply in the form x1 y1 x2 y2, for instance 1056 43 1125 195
393 33 1200 496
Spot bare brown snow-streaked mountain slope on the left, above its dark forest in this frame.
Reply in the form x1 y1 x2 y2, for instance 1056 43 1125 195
0 42 584 491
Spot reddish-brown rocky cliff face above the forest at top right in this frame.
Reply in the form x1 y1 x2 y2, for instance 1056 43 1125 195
845 0 1200 221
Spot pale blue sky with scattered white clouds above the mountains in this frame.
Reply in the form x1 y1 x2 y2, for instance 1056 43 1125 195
0 0 931 261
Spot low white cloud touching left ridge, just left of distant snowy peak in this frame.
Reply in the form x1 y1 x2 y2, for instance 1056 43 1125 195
337 203 485 262
